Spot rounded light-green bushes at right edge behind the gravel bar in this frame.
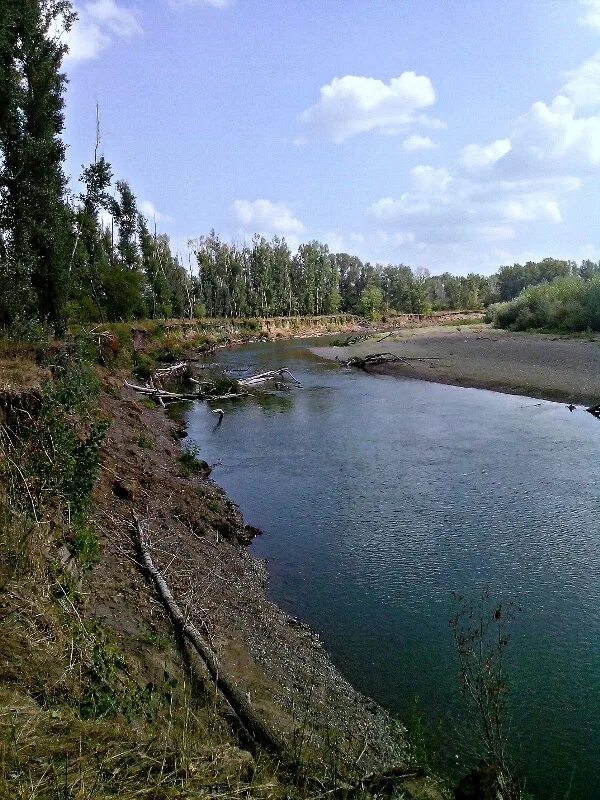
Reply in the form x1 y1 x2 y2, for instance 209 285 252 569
490 276 600 332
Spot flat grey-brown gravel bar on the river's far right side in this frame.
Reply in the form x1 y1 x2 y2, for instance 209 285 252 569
312 325 600 405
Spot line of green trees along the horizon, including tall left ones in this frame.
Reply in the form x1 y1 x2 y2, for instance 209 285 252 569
0 0 599 335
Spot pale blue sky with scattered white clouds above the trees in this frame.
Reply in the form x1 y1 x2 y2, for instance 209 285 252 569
58 0 600 274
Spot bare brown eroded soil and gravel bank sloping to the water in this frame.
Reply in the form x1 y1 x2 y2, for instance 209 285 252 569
86 376 414 774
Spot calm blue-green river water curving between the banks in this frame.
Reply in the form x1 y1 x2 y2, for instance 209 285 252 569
188 340 600 800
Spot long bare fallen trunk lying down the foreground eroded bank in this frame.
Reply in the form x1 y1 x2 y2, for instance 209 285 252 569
132 512 286 757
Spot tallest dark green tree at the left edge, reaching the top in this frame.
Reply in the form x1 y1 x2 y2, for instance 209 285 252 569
0 0 75 334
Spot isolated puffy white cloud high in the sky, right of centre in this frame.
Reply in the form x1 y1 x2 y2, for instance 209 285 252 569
296 72 443 144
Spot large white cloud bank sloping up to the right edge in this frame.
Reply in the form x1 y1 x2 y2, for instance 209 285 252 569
369 46 600 256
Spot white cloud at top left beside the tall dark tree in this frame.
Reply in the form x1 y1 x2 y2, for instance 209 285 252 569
56 0 142 65
